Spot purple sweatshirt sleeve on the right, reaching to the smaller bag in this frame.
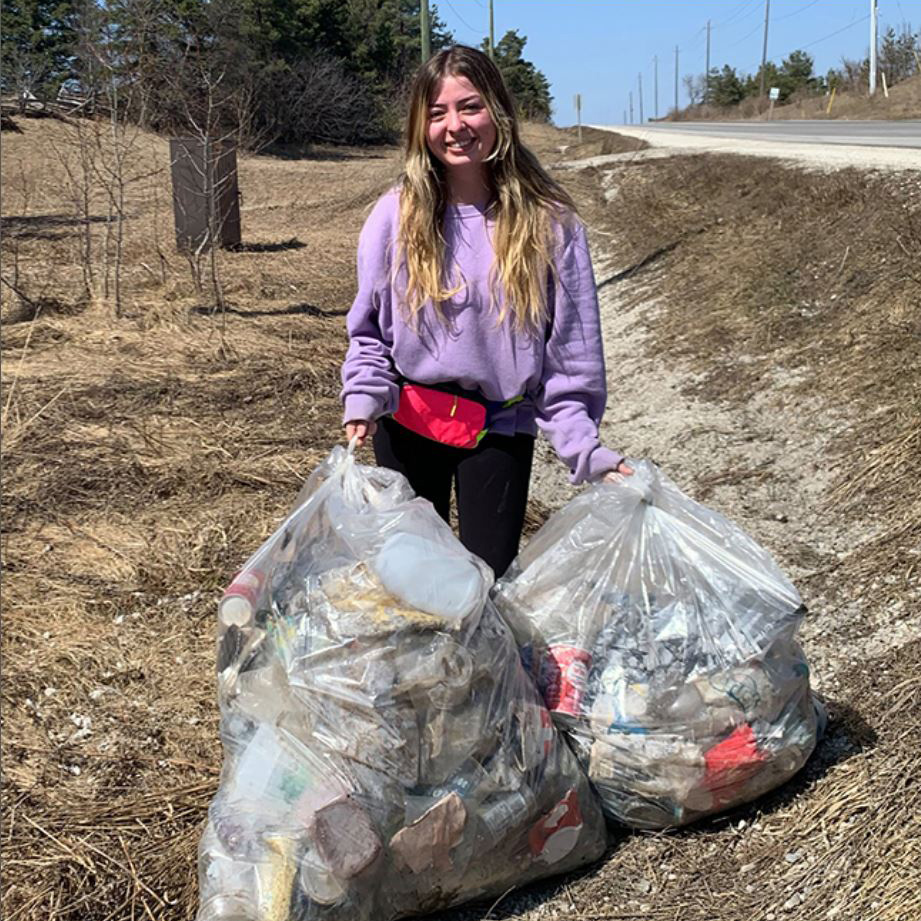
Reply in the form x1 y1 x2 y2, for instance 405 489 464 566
536 222 623 483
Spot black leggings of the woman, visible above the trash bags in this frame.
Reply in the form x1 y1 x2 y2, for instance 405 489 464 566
374 416 534 578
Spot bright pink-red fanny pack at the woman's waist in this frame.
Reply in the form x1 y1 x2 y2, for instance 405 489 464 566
393 382 524 448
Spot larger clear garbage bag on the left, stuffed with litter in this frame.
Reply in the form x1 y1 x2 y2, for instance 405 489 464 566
198 448 605 921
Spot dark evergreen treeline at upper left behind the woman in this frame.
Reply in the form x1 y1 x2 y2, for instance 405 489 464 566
0 0 552 147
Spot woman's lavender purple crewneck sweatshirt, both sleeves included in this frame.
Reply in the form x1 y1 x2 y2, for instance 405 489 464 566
342 189 623 483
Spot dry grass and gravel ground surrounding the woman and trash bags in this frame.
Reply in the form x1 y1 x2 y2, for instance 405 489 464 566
0 115 921 921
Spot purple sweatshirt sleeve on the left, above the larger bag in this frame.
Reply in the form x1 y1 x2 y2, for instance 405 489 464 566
341 192 399 423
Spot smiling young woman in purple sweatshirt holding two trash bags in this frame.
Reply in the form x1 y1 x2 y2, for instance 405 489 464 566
342 45 632 577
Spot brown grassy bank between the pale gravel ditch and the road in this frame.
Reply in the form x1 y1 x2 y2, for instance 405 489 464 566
596 156 921 612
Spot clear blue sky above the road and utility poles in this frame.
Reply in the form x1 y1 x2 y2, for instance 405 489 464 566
430 0 921 125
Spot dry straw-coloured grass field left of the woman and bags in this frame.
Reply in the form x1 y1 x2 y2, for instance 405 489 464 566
0 113 398 919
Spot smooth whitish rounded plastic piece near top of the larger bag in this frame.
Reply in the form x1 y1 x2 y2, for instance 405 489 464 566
371 531 488 624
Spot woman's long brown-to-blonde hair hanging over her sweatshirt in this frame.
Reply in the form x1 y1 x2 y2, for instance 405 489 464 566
398 45 576 331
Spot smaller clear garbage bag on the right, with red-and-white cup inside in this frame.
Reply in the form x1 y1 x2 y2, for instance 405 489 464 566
493 461 821 828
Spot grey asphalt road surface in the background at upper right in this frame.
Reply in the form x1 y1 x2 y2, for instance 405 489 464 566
605 120 921 149
